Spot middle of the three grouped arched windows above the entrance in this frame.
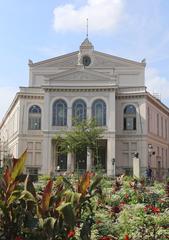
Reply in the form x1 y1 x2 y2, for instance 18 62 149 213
72 99 86 125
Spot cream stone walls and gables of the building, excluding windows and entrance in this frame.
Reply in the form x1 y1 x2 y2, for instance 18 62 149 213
0 39 169 178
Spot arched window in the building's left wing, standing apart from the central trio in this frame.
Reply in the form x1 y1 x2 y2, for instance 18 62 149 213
28 105 41 130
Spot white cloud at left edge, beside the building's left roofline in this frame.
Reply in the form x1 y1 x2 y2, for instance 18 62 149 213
0 87 18 122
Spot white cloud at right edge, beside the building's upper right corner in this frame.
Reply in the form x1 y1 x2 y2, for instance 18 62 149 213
146 68 169 100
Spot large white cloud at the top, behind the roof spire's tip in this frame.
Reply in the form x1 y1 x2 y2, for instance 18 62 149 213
54 0 124 33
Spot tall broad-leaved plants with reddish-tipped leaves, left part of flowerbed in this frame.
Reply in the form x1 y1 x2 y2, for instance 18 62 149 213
0 152 103 240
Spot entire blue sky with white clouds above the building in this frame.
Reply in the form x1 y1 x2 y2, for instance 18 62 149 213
0 0 169 121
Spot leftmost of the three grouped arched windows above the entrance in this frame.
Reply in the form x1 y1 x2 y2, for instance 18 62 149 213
53 99 67 126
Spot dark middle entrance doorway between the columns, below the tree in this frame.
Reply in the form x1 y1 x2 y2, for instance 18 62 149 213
75 149 87 172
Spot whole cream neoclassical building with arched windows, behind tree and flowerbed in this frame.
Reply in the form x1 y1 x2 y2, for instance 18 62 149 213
0 38 169 177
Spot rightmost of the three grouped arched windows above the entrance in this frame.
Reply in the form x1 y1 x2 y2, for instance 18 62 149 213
92 99 106 126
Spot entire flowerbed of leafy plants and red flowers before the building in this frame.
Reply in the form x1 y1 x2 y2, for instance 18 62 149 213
0 153 169 240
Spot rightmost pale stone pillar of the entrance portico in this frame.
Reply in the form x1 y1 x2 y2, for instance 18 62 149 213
107 138 115 176
